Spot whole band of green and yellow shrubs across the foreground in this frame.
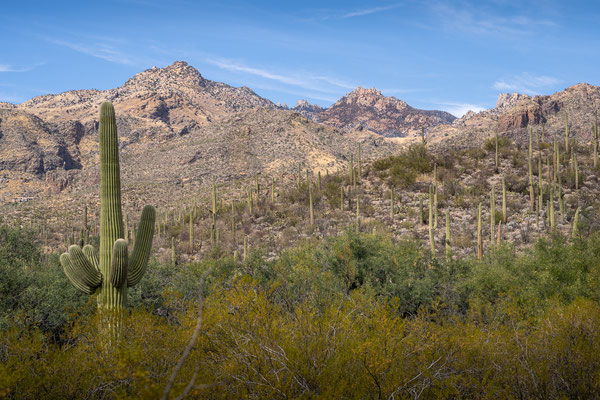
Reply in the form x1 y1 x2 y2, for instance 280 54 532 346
0 223 600 399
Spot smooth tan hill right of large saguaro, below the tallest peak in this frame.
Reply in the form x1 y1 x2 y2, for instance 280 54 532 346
115 108 398 197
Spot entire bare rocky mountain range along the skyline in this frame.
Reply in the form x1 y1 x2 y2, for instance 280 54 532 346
0 61 600 208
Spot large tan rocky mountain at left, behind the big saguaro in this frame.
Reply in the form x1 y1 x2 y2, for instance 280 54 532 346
0 62 398 202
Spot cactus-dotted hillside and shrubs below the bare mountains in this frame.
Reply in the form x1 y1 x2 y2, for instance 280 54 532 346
0 102 600 399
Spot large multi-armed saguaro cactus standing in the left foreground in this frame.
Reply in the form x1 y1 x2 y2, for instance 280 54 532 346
60 102 156 310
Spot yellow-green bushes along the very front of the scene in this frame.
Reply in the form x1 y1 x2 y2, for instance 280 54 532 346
0 278 600 399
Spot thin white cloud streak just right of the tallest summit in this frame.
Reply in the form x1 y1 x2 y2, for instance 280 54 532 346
205 57 356 94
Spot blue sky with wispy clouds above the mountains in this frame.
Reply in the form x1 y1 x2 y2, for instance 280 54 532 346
0 0 600 115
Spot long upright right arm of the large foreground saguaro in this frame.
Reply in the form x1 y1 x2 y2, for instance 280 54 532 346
127 206 156 287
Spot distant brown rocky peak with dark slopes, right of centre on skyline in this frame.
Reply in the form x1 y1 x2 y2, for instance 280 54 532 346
314 87 456 137
